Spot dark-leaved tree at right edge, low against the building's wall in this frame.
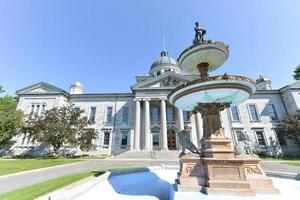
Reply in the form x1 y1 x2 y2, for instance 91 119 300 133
280 114 300 147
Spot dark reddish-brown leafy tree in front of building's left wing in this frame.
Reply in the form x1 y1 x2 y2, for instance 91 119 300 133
23 105 97 155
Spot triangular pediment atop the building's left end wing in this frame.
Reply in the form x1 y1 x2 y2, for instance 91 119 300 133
17 82 67 94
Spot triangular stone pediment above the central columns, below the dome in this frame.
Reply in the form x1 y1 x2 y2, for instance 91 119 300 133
132 73 189 90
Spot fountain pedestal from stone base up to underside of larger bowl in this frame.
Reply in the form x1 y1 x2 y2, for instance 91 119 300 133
177 103 278 195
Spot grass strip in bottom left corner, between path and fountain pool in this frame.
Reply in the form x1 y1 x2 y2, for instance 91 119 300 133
0 171 105 200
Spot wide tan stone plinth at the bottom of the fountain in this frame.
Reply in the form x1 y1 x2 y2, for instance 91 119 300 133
177 148 279 195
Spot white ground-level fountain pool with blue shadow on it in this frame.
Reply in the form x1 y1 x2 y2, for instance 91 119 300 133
39 166 300 200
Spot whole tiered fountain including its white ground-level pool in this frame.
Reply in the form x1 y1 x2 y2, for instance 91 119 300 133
39 23 300 200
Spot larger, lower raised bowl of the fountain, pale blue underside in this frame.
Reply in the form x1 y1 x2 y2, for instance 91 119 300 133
169 74 256 111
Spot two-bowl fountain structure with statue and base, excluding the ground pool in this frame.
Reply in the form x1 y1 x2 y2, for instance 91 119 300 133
168 22 279 195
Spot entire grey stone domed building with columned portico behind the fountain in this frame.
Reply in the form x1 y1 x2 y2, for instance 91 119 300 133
5 51 300 158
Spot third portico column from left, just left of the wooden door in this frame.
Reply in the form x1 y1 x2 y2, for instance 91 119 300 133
160 99 168 150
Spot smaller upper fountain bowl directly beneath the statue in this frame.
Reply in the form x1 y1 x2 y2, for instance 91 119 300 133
177 40 229 74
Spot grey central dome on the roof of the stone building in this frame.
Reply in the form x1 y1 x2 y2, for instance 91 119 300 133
149 50 181 76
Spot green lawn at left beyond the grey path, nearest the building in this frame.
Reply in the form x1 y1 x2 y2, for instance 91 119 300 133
0 158 83 176
